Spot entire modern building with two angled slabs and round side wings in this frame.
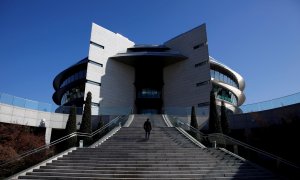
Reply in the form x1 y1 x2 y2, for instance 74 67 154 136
53 23 245 115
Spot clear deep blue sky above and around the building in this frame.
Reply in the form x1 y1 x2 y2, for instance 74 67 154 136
0 0 300 104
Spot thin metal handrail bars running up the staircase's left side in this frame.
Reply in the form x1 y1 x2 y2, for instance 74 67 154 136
0 116 121 167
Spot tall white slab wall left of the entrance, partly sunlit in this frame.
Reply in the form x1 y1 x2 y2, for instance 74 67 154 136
84 23 134 114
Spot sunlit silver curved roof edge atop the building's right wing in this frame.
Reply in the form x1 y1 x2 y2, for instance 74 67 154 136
209 57 245 91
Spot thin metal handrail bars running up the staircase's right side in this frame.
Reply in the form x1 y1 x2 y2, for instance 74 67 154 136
169 115 300 169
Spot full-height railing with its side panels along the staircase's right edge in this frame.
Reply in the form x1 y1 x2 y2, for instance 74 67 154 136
168 116 300 178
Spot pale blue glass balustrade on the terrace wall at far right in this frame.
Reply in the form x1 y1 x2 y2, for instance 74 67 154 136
240 92 300 113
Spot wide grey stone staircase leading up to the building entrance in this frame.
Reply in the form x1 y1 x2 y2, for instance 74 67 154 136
19 115 278 179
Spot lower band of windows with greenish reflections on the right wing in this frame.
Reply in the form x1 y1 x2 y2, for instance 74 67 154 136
213 84 237 106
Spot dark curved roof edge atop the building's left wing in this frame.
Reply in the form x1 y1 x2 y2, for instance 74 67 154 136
53 58 88 90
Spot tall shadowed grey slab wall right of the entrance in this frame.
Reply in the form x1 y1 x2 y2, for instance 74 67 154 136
163 24 211 107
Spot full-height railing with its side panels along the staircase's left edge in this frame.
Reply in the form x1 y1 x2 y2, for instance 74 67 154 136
0 115 128 179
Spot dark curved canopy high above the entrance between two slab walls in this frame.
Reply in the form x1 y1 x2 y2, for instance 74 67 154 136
110 51 187 66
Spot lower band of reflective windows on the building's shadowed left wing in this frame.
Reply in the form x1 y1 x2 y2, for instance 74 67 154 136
61 84 84 104
